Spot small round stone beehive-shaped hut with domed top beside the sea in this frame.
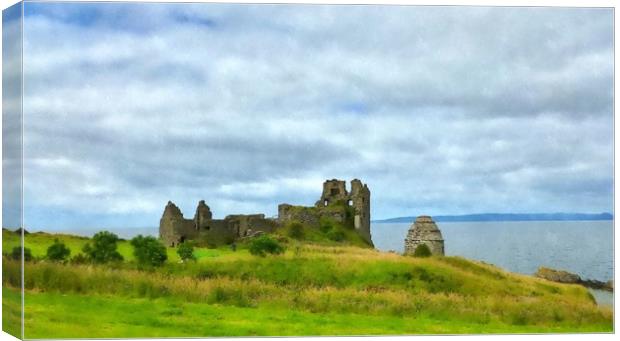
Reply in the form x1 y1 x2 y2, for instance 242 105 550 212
405 216 444 256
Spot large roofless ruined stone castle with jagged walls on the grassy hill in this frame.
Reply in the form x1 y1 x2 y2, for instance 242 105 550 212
159 179 372 246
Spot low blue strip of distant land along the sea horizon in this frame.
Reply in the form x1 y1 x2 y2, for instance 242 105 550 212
372 212 614 223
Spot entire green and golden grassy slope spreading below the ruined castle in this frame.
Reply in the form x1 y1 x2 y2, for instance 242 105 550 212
3 227 613 338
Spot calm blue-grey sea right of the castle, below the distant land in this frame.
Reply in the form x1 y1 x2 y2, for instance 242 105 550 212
371 221 614 305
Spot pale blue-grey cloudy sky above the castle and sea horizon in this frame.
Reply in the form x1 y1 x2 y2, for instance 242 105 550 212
12 3 613 229
